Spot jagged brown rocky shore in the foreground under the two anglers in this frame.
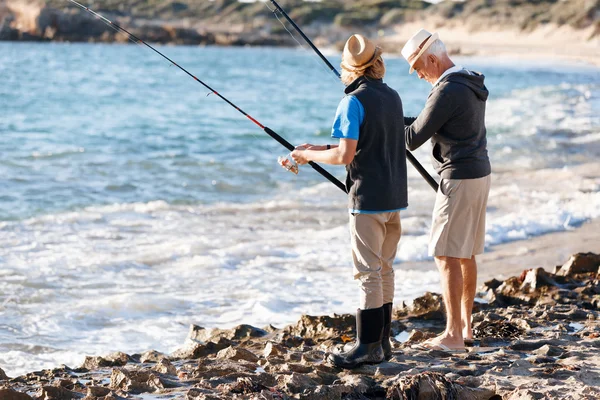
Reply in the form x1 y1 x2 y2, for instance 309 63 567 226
0 253 600 400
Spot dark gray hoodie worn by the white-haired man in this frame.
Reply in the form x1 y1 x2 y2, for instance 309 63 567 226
404 70 491 179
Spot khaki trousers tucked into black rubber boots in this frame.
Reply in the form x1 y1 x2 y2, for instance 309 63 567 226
350 211 402 310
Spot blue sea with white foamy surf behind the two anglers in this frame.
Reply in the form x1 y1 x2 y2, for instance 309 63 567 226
0 43 600 376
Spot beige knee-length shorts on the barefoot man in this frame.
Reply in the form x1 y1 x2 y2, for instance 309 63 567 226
429 175 492 258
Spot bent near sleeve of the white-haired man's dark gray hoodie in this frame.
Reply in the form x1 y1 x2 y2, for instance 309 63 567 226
404 90 454 150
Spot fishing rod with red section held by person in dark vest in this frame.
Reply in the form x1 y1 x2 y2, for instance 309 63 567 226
68 0 347 193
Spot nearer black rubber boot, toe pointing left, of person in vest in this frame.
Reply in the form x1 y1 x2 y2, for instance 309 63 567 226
327 307 384 369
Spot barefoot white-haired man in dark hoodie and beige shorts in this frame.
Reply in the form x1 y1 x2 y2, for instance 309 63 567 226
402 29 491 351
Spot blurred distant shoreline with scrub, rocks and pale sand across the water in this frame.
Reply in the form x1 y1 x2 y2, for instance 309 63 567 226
0 0 600 63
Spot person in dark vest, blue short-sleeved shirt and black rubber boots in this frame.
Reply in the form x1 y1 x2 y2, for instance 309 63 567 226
292 35 408 368
